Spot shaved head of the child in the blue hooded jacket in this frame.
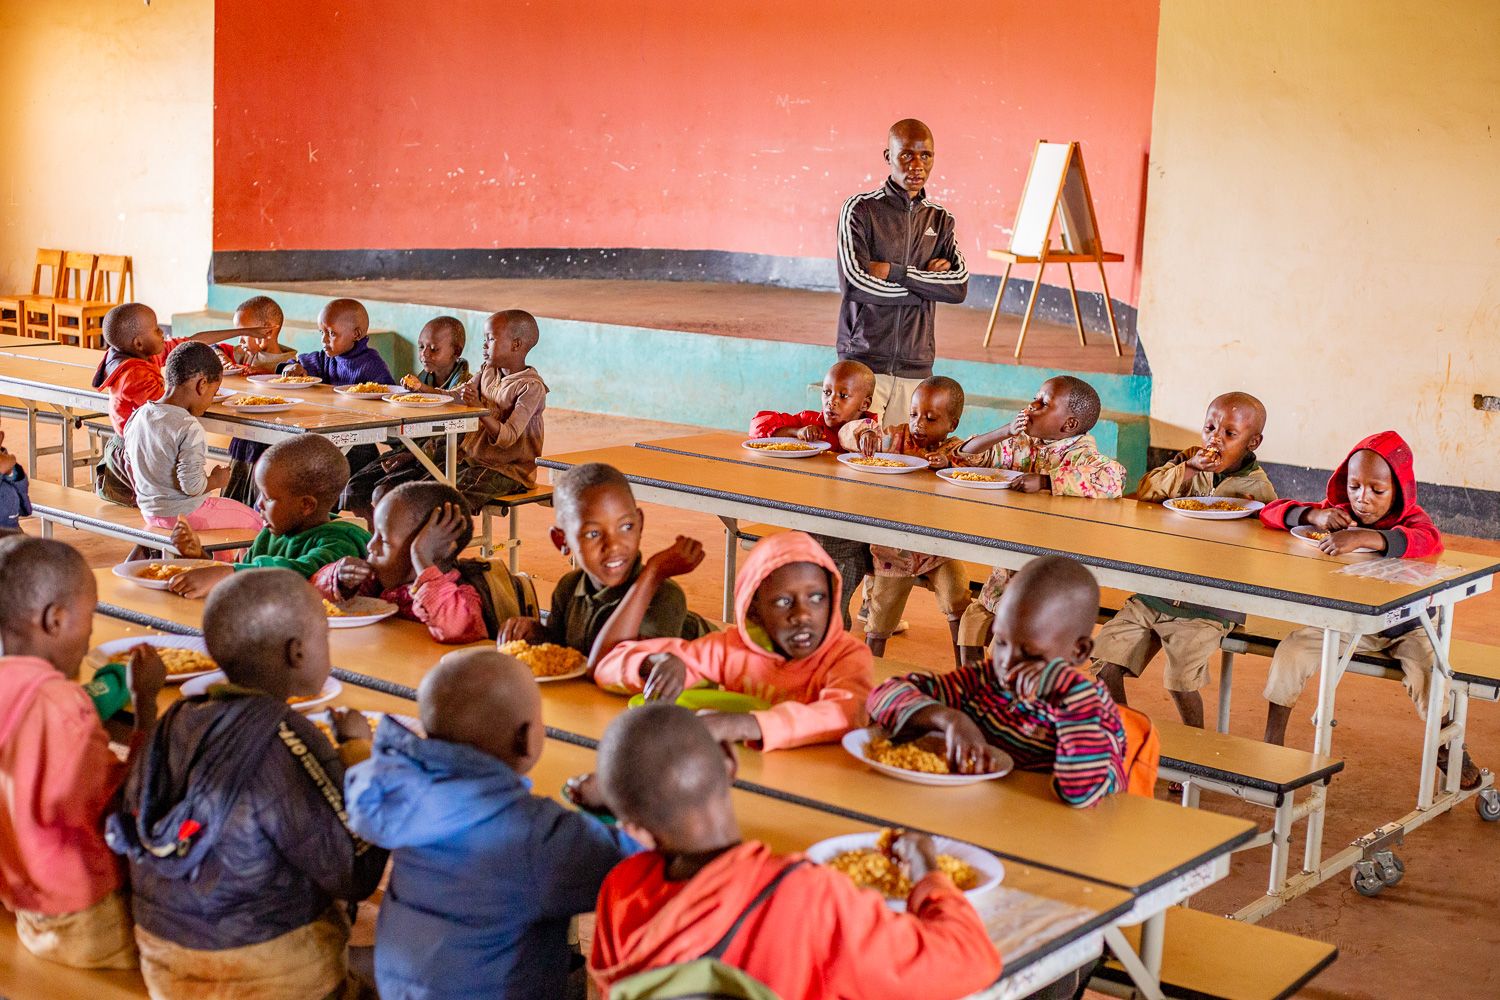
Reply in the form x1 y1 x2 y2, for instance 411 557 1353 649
417 648 546 774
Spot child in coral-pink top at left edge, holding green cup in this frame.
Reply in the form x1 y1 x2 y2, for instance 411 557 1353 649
0 537 167 969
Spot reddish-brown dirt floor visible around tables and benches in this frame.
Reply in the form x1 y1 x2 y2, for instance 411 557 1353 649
14 411 1500 999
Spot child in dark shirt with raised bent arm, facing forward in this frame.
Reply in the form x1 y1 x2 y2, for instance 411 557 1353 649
500 462 713 657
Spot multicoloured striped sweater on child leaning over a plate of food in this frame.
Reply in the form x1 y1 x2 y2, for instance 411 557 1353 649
869 660 1125 807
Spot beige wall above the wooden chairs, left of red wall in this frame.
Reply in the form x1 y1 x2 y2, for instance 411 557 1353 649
0 0 213 321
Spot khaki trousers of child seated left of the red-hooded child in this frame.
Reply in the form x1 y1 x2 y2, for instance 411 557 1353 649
1094 597 1233 691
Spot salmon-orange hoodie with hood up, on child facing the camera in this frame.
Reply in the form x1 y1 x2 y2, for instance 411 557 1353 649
594 531 875 750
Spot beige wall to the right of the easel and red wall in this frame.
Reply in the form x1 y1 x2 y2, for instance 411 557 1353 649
1140 0 1500 489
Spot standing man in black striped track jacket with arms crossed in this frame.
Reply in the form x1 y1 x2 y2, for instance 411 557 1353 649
839 118 969 427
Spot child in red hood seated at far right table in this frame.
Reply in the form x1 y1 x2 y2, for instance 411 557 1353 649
1260 430 1479 789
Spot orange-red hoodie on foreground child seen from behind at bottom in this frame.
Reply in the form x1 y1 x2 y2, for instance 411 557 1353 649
588 841 1001 1000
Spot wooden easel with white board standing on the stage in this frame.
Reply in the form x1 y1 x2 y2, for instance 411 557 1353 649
984 141 1125 358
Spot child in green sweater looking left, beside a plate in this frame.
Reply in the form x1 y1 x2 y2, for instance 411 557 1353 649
167 433 371 598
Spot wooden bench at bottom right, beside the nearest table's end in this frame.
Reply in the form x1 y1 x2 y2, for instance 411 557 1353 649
1091 907 1338 1000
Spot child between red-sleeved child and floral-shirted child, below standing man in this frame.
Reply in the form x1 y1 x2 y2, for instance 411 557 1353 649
857 375 977 657
